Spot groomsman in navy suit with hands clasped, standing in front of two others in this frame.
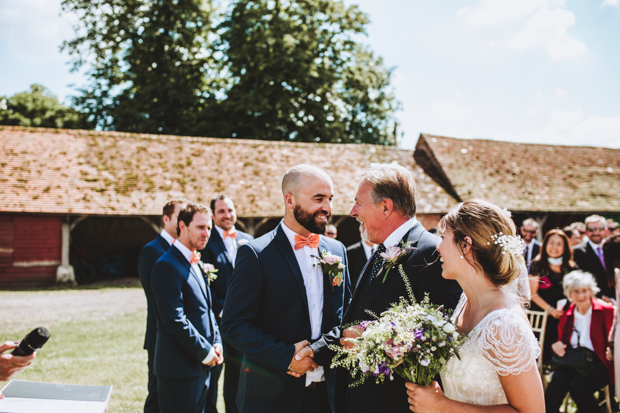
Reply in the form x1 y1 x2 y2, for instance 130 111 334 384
151 203 224 413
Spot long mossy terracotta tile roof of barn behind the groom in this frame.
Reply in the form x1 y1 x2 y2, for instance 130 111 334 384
0 126 455 217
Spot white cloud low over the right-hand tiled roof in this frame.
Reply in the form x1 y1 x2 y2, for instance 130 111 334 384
498 109 620 148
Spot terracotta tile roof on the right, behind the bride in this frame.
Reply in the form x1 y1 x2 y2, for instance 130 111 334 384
414 134 620 212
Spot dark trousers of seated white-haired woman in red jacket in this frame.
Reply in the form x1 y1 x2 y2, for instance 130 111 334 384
545 355 609 413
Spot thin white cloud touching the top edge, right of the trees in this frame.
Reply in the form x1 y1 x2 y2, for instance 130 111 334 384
456 0 564 26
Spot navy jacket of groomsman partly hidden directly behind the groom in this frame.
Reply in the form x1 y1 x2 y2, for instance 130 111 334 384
200 228 254 316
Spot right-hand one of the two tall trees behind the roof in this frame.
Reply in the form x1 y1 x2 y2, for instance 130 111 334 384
214 0 399 145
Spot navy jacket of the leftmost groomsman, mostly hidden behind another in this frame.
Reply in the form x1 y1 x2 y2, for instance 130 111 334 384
138 235 170 351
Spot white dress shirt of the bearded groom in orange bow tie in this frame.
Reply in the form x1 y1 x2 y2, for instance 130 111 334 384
282 221 325 386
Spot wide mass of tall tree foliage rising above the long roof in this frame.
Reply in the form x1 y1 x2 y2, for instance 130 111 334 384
62 0 399 145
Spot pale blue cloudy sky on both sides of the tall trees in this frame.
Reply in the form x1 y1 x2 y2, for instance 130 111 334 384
0 0 620 148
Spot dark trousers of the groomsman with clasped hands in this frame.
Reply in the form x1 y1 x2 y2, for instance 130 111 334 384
157 373 210 413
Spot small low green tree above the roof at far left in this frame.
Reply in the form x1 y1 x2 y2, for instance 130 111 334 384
0 84 89 129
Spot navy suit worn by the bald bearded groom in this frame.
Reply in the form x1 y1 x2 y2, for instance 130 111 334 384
221 224 349 413
